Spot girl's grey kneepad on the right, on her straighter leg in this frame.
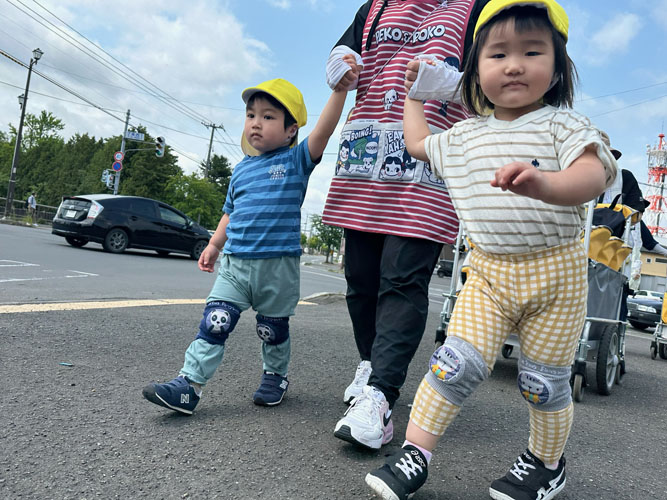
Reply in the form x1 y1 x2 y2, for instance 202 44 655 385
517 356 572 412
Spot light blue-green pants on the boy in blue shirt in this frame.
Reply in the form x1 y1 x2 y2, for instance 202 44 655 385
180 254 300 385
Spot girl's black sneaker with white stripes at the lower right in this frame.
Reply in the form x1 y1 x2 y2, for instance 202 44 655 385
489 450 565 500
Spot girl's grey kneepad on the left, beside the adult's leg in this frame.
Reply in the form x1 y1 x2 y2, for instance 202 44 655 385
426 337 489 406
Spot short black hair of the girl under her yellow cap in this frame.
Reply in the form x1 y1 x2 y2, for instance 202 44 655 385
459 5 578 116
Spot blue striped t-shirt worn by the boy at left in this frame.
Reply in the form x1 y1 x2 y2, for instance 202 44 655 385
223 138 316 259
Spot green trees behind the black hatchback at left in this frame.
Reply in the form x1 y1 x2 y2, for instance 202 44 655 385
0 111 232 224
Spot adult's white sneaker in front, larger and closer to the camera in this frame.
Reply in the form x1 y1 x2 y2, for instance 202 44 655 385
334 385 394 450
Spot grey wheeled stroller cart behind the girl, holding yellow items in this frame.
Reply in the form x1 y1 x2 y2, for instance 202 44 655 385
436 196 636 402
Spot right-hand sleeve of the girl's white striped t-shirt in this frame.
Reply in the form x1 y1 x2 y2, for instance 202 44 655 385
555 113 620 188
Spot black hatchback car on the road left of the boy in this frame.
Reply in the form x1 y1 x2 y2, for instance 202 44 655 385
51 194 211 260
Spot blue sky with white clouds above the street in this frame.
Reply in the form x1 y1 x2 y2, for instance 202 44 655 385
0 0 667 222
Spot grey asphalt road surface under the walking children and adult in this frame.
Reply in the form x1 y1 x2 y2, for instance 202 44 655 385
0 225 667 500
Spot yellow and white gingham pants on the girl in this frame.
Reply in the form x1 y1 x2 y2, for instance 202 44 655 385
410 241 588 463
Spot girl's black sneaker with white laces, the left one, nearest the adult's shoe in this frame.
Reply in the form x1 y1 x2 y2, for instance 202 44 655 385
366 445 428 500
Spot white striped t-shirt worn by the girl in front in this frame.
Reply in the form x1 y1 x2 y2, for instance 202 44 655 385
425 106 618 254
